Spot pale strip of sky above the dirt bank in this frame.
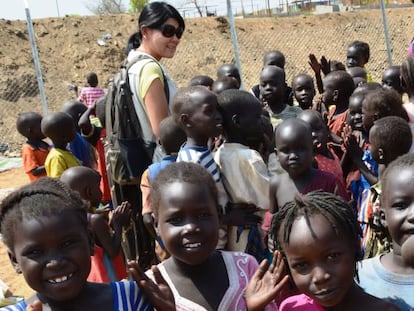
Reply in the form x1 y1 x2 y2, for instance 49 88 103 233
0 0 266 20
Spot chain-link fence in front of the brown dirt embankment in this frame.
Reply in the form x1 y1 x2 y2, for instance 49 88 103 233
0 6 414 153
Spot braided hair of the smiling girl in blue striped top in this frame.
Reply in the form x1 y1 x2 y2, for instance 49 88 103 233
0 177 88 249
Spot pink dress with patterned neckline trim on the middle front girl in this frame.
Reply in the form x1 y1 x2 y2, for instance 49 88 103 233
146 251 278 311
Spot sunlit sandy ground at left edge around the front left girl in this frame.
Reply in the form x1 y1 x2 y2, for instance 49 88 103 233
0 168 33 297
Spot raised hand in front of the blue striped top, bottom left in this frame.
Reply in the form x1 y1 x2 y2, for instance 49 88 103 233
129 260 175 311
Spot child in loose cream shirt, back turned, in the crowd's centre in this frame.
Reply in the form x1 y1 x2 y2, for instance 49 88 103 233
214 90 270 262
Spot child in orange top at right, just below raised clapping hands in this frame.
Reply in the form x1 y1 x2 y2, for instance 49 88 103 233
322 70 355 138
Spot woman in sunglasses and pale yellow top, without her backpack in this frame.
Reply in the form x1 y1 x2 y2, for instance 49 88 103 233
127 2 185 161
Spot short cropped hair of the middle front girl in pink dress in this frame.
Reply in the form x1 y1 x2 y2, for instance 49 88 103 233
151 162 220 217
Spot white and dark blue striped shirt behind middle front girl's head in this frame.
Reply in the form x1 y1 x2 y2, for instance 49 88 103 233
177 145 220 182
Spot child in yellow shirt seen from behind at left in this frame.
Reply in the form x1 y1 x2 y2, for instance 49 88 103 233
41 112 80 178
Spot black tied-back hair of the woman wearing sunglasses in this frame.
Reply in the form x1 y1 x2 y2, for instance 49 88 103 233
126 1 185 55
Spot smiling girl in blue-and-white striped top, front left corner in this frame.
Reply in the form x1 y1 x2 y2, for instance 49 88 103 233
0 177 175 310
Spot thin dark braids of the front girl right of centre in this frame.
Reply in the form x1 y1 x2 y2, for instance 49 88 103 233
270 191 362 272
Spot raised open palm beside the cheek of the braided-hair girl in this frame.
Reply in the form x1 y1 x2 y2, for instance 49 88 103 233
245 251 289 311
